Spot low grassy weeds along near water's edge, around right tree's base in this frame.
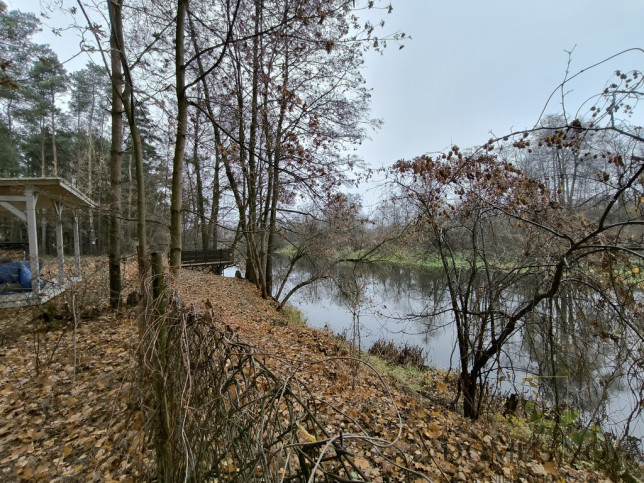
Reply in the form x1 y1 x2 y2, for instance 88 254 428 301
365 341 644 481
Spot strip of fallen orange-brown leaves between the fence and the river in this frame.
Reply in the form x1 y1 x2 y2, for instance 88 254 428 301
172 272 605 481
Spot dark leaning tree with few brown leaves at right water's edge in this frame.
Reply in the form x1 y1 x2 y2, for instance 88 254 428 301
394 122 644 424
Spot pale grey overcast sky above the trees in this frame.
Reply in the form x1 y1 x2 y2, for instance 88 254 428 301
13 0 644 182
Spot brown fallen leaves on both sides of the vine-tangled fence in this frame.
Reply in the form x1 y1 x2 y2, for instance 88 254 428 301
0 267 604 481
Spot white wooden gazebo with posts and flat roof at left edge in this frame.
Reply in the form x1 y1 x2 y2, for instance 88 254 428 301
0 178 94 308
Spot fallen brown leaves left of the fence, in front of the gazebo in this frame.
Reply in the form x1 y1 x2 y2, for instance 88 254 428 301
0 260 145 481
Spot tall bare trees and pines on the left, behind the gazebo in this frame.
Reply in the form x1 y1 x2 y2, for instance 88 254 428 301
2 1 404 300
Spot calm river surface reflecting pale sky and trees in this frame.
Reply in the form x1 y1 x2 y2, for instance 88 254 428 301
280 264 644 437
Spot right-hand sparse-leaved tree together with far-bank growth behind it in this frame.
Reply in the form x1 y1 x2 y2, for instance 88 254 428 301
266 61 644 476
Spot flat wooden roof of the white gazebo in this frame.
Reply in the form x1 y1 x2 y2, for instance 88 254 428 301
0 178 95 210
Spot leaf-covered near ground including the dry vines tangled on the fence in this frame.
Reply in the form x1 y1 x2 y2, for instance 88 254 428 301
0 266 637 481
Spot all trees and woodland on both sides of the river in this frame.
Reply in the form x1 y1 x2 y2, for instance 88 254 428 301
0 0 644 476
